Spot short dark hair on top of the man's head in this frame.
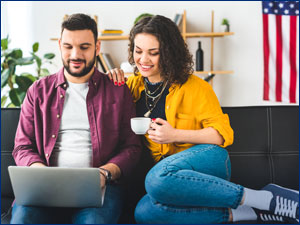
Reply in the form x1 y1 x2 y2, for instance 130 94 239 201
61 13 98 43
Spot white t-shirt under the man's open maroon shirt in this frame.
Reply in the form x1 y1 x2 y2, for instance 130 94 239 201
50 82 92 167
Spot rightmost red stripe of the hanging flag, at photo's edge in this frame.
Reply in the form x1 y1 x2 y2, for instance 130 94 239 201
289 16 297 103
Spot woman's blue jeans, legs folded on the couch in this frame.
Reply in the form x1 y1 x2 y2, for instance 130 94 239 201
135 144 244 224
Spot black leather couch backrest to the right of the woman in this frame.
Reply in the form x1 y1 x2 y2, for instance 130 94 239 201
223 106 299 190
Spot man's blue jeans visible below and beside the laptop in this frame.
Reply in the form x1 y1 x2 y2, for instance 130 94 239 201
10 185 123 224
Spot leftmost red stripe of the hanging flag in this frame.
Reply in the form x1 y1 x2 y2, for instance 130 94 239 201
263 14 270 100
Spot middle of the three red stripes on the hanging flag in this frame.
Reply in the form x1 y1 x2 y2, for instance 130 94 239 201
276 15 282 102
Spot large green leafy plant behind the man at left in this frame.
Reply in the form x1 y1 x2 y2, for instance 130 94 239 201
1 37 55 107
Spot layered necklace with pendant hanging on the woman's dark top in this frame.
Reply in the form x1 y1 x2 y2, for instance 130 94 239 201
144 79 168 117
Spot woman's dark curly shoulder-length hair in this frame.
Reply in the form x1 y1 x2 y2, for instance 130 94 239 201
128 15 194 84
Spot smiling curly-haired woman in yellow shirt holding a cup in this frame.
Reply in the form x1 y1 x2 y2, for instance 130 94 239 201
109 15 299 223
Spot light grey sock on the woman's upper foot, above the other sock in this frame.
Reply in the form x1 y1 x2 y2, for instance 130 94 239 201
242 188 273 210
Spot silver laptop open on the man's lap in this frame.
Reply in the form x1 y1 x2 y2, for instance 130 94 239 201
8 166 105 207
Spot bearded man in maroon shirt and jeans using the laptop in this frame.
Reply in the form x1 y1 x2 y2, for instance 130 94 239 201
11 14 141 224
